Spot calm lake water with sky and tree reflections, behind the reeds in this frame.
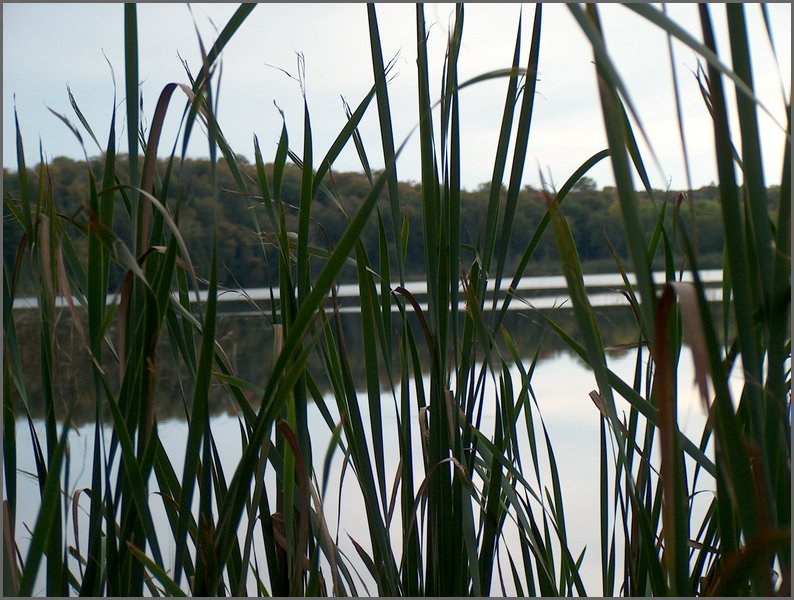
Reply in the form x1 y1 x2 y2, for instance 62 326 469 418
7 272 741 595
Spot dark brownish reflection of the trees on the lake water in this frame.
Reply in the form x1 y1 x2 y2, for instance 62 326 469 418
14 305 719 425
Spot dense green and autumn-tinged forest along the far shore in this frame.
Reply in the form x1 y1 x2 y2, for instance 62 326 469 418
3 156 779 289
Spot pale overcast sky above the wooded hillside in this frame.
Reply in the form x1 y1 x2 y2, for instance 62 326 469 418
3 3 791 189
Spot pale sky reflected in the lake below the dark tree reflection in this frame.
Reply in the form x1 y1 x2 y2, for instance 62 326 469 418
10 349 741 594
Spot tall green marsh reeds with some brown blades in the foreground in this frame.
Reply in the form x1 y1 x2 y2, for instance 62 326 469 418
3 4 791 596
